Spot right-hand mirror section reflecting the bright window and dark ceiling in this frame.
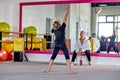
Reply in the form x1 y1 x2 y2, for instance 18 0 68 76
91 2 120 54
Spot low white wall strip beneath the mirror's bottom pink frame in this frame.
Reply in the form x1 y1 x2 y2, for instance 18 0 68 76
26 53 120 66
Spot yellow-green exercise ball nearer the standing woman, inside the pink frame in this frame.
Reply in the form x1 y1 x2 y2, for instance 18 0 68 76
23 26 37 37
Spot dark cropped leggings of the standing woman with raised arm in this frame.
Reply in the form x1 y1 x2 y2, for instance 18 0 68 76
51 45 70 60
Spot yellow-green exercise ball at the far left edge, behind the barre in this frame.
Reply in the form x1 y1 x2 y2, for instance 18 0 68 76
0 22 10 37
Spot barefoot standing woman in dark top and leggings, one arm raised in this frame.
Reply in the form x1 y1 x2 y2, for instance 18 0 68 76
45 6 74 73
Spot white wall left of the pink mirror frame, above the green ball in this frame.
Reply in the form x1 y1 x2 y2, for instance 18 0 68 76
0 0 67 32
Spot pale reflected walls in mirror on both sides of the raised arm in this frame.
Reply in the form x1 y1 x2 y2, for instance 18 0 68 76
22 3 91 51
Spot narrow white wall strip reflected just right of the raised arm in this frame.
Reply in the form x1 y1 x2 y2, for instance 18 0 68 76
69 4 79 51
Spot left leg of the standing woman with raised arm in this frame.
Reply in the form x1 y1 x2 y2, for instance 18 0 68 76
45 47 59 73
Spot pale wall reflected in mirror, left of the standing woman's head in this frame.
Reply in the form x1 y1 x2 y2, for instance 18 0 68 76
22 5 55 34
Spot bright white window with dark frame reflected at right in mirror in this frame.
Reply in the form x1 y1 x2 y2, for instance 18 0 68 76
98 15 120 42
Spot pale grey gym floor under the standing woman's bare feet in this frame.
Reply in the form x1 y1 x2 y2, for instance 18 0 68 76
0 61 120 80
